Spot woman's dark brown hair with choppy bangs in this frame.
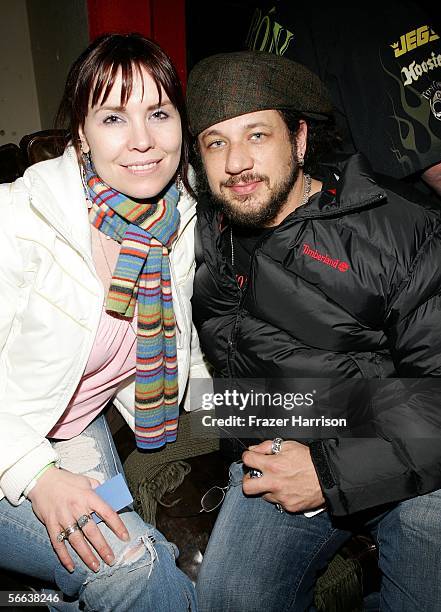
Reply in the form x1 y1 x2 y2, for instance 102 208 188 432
55 33 193 194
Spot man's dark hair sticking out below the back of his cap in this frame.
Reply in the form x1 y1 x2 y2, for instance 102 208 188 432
278 110 342 177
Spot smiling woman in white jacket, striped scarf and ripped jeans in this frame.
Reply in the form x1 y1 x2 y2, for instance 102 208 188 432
0 35 207 612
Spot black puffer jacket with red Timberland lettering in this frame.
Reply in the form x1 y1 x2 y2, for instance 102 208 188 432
193 155 441 515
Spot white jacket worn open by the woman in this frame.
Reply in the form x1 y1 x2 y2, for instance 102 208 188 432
0 148 208 504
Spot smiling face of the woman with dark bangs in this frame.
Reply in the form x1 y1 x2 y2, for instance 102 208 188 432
80 68 182 199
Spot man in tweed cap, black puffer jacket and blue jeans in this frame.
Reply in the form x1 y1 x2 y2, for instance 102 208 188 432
187 51 441 612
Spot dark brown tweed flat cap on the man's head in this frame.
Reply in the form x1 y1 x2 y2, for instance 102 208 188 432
187 51 332 136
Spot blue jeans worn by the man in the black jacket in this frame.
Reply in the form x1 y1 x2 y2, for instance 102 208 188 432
196 463 441 612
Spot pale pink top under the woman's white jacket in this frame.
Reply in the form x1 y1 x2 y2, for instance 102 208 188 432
48 226 136 440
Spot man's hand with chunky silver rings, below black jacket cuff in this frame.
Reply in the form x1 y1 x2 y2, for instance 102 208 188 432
242 440 325 512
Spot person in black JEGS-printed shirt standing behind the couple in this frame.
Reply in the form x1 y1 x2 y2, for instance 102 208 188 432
244 0 441 198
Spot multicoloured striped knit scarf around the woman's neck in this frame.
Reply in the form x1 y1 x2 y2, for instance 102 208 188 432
85 167 180 449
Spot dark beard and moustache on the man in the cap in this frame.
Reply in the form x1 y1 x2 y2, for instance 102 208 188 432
200 151 299 227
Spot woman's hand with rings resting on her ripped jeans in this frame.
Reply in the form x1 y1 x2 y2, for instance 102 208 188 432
28 466 129 572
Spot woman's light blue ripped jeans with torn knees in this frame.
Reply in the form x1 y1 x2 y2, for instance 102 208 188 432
0 416 197 612
